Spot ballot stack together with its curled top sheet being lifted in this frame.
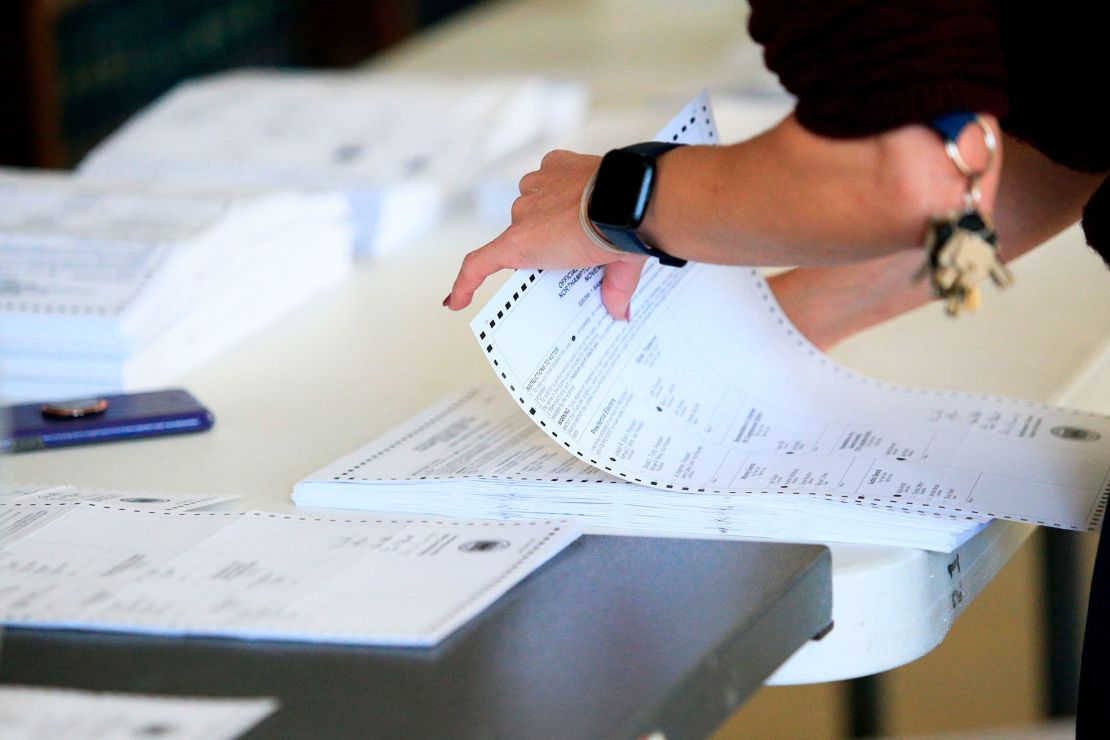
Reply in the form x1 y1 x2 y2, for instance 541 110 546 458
294 93 1110 551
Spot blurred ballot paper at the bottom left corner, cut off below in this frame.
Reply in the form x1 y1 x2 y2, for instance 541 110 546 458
0 686 278 740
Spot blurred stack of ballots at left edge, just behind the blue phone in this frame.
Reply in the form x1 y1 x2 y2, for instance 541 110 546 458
0 170 352 401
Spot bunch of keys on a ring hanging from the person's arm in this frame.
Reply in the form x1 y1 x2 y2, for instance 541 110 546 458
917 113 1013 316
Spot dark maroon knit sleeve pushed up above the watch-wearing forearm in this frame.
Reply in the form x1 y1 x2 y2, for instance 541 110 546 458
749 0 1008 138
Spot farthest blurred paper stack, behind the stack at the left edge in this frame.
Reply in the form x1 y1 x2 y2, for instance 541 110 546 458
81 70 586 254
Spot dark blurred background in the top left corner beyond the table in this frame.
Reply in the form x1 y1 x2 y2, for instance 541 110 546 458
0 0 475 168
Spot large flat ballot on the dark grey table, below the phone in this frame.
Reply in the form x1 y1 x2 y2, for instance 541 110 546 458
0 503 575 646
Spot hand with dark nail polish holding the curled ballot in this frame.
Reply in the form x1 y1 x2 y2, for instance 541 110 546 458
443 151 645 321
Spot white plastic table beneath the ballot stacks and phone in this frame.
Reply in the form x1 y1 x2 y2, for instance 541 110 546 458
4 0 1110 683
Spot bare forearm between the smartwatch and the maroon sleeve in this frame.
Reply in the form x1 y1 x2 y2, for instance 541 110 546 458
642 118 998 265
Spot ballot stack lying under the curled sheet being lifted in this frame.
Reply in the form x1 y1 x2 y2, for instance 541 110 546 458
293 386 989 553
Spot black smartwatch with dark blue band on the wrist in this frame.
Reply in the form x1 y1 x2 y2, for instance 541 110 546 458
582 141 686 267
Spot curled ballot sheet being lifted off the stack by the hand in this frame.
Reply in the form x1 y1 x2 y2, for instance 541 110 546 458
472 90 1110 530
